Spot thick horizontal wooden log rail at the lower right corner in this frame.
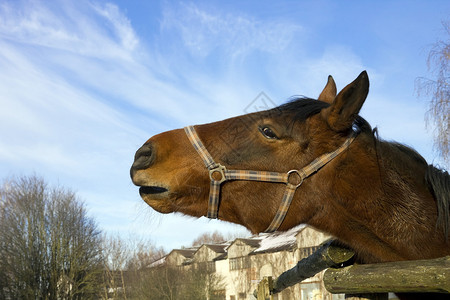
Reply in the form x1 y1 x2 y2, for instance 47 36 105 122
323 256 450 296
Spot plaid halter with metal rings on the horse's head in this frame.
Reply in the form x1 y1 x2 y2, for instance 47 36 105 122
184 126 359 232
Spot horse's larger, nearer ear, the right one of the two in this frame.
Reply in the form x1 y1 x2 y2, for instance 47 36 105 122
322 71 369 131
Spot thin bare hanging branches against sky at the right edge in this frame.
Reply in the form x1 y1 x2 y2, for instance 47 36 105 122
416 22 450 166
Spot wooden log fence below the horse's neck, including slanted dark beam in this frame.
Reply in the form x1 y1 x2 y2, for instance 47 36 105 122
254 241 450 300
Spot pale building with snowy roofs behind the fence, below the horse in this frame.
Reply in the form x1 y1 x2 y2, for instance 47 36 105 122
155 225 344 300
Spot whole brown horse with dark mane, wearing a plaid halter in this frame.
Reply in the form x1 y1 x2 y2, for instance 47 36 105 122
131 72 450 263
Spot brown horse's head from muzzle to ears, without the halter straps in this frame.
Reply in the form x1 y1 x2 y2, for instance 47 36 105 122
131 72 369 232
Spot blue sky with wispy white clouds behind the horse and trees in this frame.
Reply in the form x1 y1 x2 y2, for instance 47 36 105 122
0 0 450 250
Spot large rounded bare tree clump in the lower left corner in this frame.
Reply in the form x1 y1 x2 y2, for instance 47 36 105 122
0 176 101 299
